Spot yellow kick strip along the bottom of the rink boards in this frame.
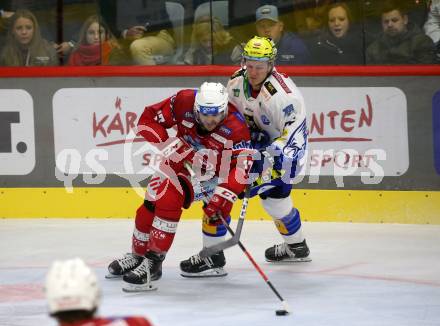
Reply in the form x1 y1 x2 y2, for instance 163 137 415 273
0 188 440 224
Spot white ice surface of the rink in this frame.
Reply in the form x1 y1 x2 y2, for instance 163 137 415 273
0 219 440 326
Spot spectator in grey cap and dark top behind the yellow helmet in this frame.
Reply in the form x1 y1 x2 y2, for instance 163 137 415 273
231 5 310 65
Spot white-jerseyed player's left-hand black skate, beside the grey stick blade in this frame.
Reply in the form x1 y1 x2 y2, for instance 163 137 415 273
180 251 228 277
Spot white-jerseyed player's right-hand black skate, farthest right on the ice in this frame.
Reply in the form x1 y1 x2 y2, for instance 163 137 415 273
264 239 312 263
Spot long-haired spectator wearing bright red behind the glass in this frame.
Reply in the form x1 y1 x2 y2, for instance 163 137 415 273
68 15 125 66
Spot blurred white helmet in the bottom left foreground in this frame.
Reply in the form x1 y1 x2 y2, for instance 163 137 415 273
45 258 101 315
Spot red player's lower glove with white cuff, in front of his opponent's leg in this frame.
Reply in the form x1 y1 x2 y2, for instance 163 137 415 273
203 186 237 225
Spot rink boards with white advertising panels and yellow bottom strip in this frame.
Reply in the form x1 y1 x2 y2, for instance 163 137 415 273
0 70 440 224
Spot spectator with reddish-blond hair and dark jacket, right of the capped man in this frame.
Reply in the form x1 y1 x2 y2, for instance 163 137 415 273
311 3 364 65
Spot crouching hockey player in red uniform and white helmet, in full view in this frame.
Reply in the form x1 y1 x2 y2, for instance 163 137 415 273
107 83 251 292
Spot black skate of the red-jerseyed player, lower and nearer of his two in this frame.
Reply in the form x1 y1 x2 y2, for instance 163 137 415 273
122 251 165 292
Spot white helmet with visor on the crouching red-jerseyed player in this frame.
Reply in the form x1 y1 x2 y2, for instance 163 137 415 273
194 82 228 123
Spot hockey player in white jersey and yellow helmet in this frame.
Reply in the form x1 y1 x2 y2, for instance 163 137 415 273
180 36 311 277
